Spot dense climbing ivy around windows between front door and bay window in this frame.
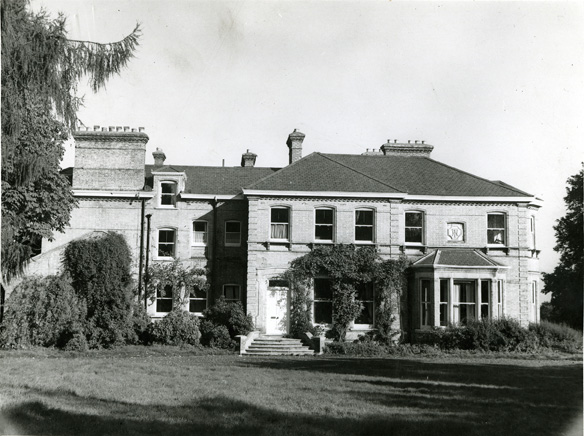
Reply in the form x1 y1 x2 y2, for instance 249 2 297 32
285 244 409 342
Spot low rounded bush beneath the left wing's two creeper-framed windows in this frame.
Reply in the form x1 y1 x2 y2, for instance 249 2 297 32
148 310 201 345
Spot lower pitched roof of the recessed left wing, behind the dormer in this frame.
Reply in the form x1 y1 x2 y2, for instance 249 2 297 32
146 165 279 195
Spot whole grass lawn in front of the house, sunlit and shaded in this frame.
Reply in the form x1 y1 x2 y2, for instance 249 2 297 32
0 347 582 436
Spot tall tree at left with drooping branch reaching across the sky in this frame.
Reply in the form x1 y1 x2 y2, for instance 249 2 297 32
0 0 140 282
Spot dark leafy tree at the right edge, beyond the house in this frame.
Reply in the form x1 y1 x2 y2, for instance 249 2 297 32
543 170 584 330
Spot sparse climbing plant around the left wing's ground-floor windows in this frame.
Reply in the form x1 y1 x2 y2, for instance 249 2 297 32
146 260 209 308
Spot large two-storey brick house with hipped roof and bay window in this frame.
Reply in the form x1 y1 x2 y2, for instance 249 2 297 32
30 126 541 340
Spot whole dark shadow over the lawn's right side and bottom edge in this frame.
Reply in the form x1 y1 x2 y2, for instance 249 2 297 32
0 358 582 436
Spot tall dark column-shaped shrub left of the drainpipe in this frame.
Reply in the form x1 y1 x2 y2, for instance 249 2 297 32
63 232 134 348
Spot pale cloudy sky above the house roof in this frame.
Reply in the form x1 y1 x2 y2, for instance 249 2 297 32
32 0 584 280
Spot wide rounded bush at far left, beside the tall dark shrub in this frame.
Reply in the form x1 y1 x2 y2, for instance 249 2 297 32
0 276 86 348
